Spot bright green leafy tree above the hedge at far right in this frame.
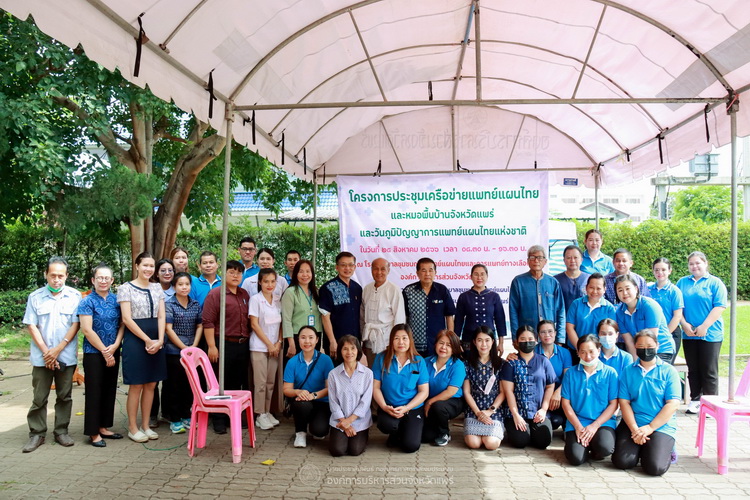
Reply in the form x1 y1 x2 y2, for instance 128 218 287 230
672 186 742 223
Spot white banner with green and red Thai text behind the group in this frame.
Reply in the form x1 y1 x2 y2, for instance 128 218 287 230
336 172 548 304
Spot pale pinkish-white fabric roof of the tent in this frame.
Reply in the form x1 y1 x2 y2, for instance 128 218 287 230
5 0 750 185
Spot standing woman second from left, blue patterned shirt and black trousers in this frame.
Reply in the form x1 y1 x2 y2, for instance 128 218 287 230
78 264 125 448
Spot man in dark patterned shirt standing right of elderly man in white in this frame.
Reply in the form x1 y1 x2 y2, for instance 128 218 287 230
403 257 456 356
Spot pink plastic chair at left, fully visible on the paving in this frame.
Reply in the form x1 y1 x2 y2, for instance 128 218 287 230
180 347 255 464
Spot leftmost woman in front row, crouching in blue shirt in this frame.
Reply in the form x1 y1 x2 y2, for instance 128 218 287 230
284 326 333 448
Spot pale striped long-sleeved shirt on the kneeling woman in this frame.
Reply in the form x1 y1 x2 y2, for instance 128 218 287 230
328 363 373 432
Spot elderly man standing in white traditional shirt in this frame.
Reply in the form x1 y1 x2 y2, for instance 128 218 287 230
360 258 406 366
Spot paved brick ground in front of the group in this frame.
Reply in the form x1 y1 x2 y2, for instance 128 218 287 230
0 361 750 500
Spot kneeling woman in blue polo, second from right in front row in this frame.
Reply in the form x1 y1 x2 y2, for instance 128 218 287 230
562 334 618 465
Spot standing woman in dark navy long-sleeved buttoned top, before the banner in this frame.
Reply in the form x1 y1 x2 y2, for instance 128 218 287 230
455 264 507 355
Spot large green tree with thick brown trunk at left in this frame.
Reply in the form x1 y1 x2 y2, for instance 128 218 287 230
0 11 320 266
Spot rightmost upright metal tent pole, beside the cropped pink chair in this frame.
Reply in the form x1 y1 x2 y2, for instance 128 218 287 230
727 100 739 402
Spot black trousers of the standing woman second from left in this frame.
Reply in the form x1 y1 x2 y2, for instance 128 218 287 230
83 350 120 436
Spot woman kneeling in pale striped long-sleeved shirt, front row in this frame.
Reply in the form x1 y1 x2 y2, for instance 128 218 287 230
328 335 373 457
